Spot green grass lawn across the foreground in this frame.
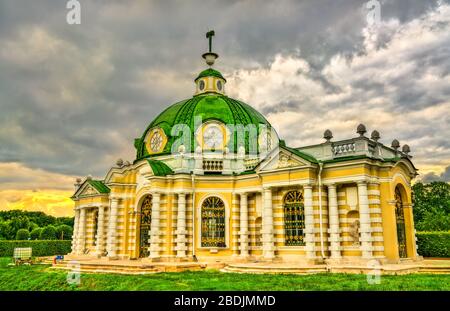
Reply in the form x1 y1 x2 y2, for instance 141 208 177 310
0 258 450 291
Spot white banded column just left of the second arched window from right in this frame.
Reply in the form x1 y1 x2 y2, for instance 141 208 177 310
262 188 275 259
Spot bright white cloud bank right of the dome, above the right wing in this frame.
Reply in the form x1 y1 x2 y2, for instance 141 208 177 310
228 1 450 178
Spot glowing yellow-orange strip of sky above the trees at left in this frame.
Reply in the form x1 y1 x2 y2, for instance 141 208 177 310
0 189 74 217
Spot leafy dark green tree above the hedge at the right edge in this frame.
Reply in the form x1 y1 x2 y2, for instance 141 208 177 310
412 181 450 231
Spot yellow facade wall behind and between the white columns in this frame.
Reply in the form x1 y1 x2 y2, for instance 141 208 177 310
75 158 416 260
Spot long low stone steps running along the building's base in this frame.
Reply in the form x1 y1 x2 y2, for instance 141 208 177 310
46 257 450 275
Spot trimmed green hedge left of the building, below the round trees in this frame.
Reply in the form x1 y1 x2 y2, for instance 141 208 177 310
0 240 72 257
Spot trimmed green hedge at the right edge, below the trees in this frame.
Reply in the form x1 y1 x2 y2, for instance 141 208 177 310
416 231 450 257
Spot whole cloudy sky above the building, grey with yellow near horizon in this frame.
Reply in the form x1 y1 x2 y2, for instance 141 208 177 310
0 0 450 213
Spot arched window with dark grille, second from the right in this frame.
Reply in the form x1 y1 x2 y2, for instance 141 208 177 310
283 191 305 246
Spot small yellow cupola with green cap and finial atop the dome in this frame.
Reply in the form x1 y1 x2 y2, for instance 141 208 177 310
195 30 227 95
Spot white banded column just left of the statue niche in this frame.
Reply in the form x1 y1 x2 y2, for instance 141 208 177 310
328 184 341 259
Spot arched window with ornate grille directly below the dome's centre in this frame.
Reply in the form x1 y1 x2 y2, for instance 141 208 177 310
201 197 226 247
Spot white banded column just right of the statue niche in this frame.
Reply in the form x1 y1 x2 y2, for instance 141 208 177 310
358 181 372 259
